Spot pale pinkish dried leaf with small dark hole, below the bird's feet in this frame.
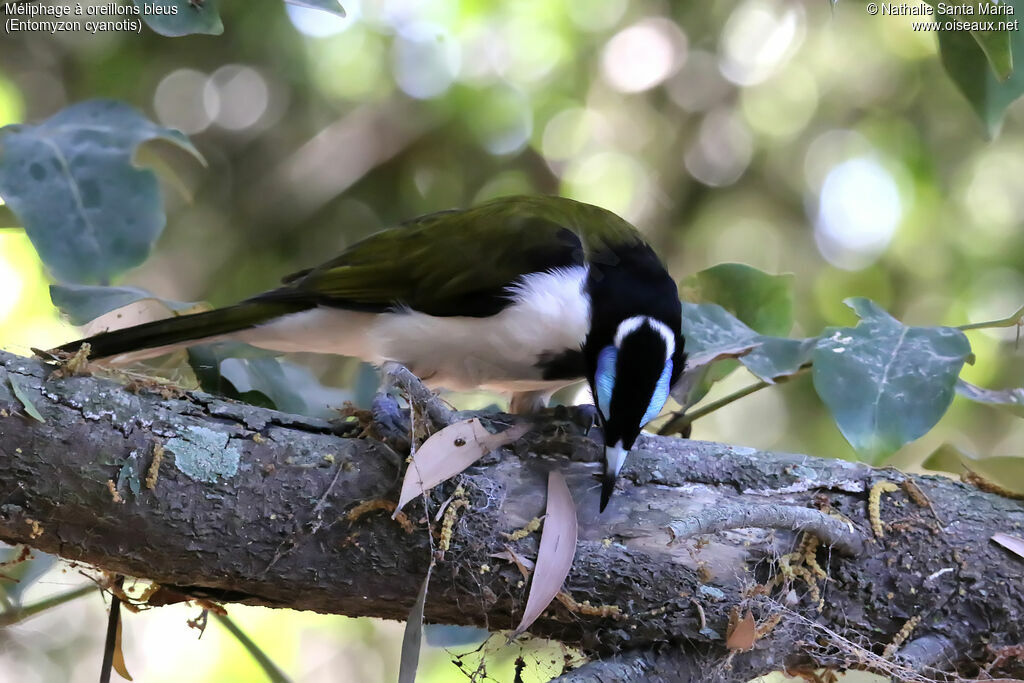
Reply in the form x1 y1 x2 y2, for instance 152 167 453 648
392 418 529 517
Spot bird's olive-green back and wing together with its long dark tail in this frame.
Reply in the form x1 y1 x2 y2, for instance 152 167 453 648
60 192 642 357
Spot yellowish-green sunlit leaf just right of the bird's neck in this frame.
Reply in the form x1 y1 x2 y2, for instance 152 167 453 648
680 263 794 337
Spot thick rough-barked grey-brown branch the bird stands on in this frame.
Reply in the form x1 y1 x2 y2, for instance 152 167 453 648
0 354 1024 681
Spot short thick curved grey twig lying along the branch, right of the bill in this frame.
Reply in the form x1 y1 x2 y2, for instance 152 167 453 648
668 505 864 555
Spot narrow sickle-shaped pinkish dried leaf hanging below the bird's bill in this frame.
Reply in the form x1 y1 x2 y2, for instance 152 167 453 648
512 470 578 637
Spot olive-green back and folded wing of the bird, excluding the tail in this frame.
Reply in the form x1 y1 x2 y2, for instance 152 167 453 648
261 198 638 316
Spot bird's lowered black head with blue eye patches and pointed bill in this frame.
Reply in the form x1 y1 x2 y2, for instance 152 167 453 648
584 245 686 512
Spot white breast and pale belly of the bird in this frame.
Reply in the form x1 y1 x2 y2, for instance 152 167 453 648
238 266 590 391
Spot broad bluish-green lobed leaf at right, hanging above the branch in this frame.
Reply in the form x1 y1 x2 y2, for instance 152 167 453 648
812 297 971 463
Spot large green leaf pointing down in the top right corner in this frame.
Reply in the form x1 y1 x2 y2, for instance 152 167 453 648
935 0 1024 137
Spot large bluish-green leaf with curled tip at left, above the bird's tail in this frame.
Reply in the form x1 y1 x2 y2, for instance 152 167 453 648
0 99 202 284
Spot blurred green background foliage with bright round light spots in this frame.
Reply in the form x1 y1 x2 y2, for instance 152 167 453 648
0 0 1024 681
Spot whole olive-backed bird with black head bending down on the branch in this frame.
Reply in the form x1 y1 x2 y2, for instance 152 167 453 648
55 196 686 512
